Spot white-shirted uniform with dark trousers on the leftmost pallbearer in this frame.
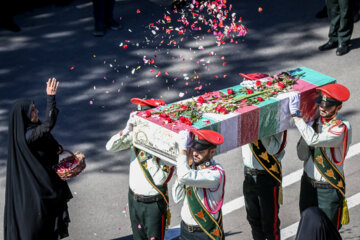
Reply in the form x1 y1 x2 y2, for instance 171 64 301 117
106 98 174 240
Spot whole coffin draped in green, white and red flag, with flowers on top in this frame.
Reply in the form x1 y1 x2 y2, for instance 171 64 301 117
133 67 336 164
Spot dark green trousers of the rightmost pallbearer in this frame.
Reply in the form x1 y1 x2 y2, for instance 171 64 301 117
299 175 344 230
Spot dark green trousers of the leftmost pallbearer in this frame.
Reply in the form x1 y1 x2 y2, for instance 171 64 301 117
128 191 167 240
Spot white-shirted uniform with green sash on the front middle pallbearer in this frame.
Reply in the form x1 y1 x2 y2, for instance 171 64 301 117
172 130 225 240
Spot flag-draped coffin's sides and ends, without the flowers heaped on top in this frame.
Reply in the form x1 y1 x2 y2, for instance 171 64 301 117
133 67 336 165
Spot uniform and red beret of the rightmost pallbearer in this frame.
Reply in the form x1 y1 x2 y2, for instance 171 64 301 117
295 84 351 230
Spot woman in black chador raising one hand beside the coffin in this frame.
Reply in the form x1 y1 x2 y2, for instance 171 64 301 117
4 78 72 240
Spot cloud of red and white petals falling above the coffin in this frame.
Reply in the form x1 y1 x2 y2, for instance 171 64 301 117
92 0 249 105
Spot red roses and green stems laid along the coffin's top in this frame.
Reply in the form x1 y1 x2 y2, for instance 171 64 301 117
145 72 301 126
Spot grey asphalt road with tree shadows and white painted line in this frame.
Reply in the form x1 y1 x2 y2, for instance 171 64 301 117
0 0 360 240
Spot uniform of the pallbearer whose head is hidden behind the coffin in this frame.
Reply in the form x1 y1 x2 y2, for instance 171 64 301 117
242 132 286 240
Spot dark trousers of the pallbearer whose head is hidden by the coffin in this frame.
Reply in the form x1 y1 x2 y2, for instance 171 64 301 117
243 171 280 240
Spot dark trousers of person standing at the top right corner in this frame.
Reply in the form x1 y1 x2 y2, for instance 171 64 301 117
326 0 354 44
